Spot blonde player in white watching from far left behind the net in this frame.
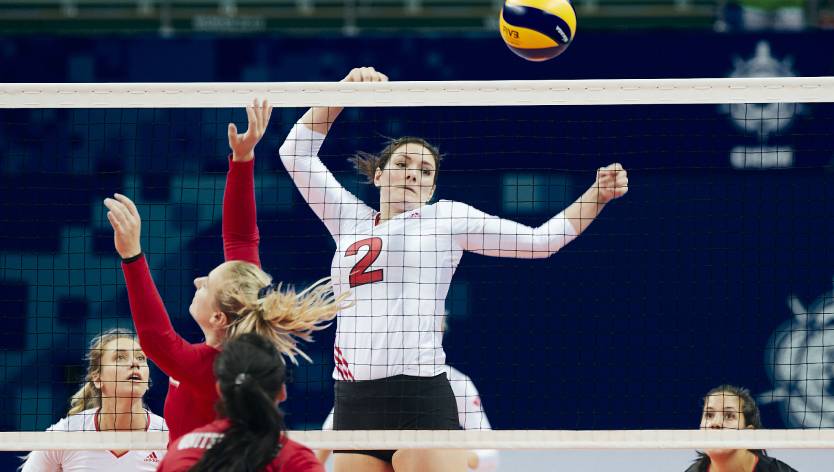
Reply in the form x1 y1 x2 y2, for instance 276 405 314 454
22 329 168 472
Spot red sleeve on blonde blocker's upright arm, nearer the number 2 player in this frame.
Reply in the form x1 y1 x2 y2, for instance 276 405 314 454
223 156 260 266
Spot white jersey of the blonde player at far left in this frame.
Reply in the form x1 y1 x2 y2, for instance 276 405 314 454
22 408 168 472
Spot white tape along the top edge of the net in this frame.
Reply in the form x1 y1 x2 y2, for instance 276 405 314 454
0 77 834 108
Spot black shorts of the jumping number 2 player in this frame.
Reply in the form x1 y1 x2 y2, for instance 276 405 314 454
333 372 461 463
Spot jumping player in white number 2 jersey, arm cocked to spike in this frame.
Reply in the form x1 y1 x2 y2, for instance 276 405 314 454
280 67 628 471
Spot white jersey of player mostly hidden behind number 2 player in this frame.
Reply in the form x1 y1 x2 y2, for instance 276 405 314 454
321 365 498 472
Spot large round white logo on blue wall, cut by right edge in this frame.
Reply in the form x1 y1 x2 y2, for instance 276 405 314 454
759 280 834 428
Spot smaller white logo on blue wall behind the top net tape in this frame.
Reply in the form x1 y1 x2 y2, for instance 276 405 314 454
721 41 802 169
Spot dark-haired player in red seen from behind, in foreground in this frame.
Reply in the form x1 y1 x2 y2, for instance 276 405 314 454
159 333 324 472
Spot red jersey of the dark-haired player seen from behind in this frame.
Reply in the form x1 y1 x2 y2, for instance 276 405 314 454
156 418 324 472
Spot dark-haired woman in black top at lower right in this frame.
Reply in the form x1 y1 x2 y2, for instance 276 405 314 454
686 385 796 472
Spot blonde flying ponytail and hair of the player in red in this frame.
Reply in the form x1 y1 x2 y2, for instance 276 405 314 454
215 261 349 364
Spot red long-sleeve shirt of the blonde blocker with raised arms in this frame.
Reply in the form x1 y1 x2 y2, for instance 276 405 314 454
122 160 261 444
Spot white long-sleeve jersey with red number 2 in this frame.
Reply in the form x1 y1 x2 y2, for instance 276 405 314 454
280 124 576 380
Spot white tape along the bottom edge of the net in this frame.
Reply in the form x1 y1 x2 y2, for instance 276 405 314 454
0 429 834 451
